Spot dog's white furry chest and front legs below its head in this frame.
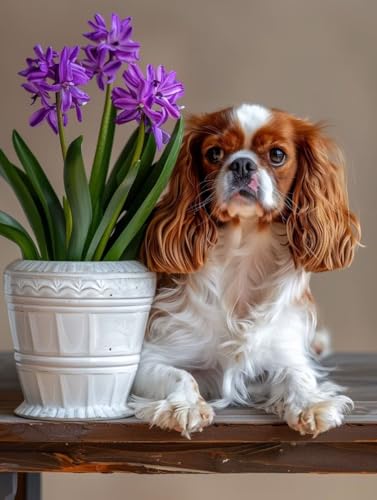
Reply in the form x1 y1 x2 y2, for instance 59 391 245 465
133 217 350 435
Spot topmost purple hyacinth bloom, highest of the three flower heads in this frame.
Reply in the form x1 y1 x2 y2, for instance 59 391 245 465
84 14 140 63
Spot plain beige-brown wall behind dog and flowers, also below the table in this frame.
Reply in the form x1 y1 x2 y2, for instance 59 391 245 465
0 0 377 500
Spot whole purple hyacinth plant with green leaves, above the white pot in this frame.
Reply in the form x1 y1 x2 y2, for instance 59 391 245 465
4 10 184 261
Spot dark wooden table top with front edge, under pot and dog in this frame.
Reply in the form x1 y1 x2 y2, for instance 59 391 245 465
0 353 377 473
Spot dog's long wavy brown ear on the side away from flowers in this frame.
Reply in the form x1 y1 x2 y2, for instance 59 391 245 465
287 120 360 272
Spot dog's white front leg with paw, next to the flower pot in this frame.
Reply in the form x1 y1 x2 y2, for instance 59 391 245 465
130 362 214 438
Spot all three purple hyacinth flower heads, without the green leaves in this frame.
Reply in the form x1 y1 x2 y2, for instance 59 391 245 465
20 14 184 149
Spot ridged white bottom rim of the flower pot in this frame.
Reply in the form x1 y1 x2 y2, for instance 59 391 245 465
14 401 134 421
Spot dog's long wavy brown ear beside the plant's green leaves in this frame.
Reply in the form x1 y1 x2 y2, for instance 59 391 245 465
141 120 217 274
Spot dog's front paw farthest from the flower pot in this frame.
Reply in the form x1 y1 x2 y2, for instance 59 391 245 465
286 396 353 438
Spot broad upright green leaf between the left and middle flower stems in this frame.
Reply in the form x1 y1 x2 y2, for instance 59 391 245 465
64 137 92 260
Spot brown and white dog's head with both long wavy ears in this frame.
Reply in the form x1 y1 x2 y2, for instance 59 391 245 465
142 104 360 274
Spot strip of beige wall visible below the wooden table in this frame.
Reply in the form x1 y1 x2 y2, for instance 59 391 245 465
43 474 377 500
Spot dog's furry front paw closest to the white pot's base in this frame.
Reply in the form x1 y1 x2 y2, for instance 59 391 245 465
132 393 215 439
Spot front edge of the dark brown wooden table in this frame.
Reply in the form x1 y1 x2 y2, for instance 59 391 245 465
0 442 377 474
